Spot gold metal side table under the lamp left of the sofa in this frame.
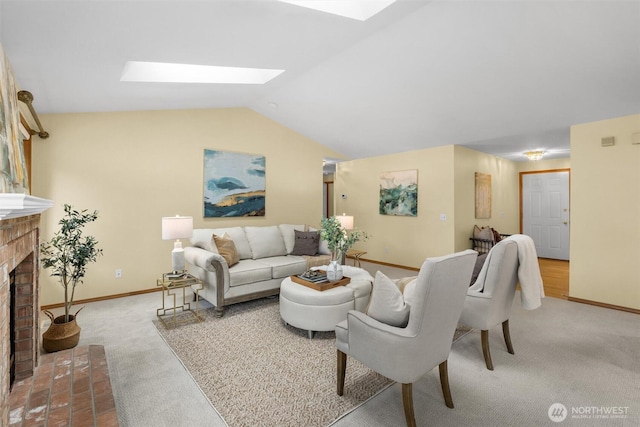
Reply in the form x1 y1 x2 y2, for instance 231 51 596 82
156 272 204 329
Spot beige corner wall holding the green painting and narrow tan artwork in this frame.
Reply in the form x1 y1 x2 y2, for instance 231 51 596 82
335 145 569 268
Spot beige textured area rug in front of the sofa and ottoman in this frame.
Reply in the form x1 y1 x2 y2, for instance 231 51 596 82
154 297 468 427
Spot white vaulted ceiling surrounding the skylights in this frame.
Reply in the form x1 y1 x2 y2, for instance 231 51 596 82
0 0 640 161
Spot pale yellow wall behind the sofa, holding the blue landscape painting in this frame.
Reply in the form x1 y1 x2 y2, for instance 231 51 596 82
32 109 340 305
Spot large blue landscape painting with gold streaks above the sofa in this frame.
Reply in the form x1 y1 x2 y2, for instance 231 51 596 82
204 149 266 218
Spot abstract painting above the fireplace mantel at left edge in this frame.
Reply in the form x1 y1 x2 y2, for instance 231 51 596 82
0 45 29 193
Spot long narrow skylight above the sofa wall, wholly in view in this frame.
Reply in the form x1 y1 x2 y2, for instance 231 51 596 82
120 61 284 84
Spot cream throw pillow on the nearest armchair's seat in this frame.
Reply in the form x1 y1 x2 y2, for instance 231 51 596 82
367 271 409 328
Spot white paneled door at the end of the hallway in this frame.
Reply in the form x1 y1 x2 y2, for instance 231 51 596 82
520 171 570 260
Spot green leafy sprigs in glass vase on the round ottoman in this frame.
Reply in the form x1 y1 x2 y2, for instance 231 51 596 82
320 216 369 281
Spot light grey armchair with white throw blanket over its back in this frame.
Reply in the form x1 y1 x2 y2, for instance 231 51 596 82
460 239 519 371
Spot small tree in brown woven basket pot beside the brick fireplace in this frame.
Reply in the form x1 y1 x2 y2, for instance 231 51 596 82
40 204 102 352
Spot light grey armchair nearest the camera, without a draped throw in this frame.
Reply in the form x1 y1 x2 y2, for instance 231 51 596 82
336 250 477 426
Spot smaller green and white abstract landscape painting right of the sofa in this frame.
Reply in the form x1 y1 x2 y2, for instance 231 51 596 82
380 170 418 216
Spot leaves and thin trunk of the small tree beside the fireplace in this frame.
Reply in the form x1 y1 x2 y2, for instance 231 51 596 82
40 204 102 322
